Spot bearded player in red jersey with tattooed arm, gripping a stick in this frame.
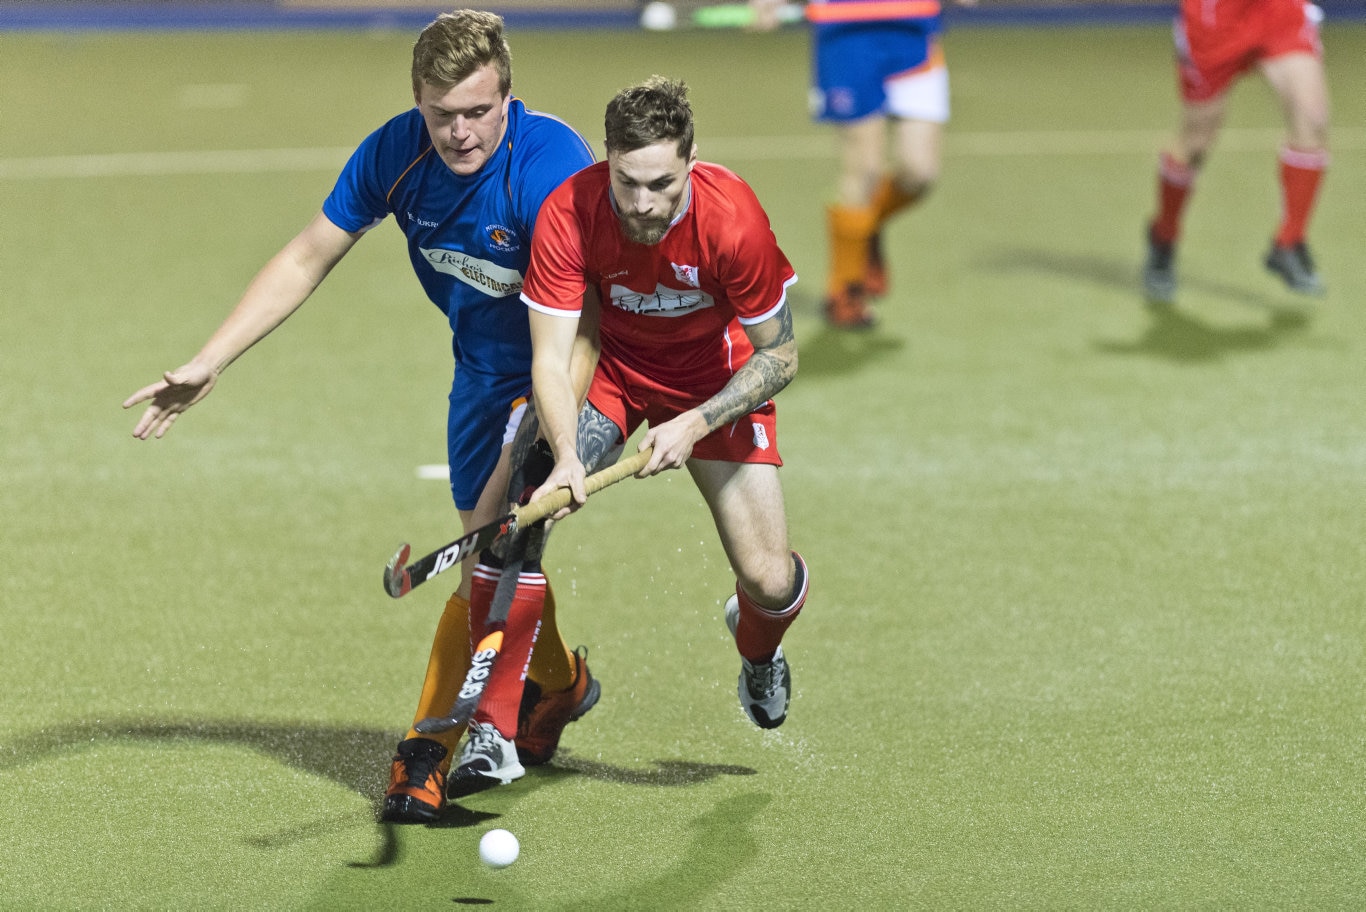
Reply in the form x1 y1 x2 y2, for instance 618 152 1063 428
522 76 807 728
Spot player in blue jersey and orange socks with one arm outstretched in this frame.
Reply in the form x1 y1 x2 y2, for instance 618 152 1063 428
123 10 598 822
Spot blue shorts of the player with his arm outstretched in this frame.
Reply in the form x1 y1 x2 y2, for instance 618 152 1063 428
445 367 531 509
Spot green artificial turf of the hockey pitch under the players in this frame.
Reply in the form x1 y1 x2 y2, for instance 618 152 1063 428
0 26 1366 909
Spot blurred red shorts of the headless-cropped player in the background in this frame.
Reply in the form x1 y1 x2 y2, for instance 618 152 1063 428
1175 0 1324 102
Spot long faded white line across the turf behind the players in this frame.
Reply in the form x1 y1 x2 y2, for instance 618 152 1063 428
0 127 1366 180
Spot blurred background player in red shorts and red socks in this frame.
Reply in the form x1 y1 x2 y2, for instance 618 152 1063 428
1143 0 1328 303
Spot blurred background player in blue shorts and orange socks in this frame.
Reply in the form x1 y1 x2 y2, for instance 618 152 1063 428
750 0 975 329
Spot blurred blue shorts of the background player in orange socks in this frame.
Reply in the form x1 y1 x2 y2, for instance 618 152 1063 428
811 19 941 123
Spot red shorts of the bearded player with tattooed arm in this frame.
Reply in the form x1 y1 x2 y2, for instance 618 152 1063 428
589 358 783 466
